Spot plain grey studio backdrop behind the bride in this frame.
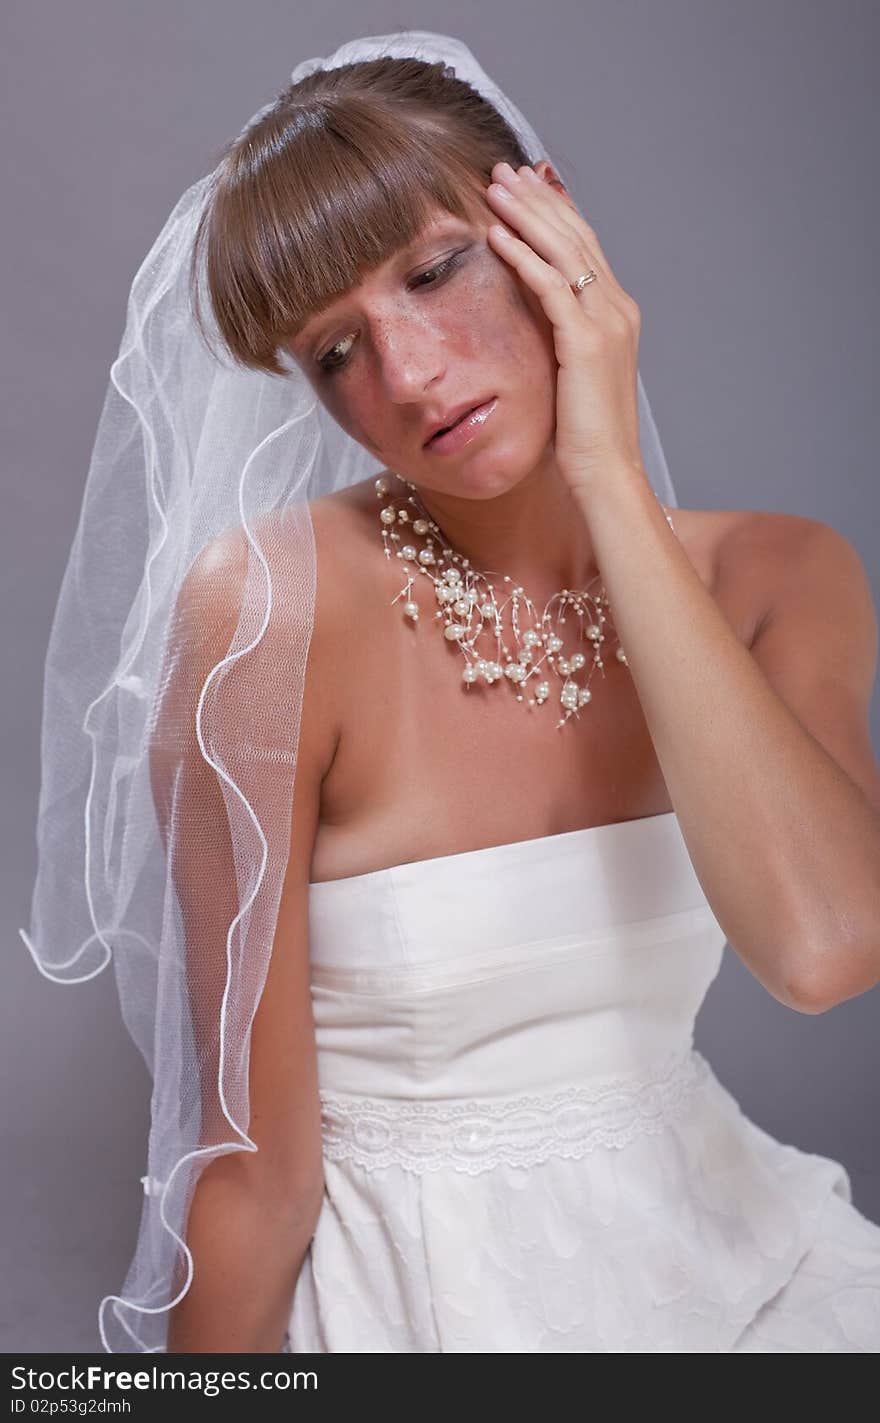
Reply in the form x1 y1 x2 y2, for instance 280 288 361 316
0 0 880 1352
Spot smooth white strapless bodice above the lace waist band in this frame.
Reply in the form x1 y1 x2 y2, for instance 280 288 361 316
309 813 725 1100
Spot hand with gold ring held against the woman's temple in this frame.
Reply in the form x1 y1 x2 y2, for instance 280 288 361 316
486 159 644 490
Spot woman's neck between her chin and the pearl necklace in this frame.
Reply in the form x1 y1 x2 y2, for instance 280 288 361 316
395 455 598 596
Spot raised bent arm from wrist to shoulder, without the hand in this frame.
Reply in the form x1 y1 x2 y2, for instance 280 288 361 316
572 483 880 1013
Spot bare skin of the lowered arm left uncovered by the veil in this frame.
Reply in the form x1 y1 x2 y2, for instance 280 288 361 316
168 768 323 1353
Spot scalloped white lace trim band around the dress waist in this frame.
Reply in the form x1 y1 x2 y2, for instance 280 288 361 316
320 1049 711 1175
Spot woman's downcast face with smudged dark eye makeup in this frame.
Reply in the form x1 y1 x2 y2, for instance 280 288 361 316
288 196 557 499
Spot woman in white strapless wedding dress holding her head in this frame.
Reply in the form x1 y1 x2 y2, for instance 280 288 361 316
18 27 880 1352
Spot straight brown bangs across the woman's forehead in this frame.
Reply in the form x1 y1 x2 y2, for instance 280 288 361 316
192 98 491 374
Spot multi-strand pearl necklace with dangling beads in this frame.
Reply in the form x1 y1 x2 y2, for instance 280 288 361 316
374 475 675 727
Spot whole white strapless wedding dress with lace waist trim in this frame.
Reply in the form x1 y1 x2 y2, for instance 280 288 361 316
285 813 880 1353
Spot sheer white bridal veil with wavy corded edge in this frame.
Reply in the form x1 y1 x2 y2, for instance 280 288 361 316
20 31 676 1352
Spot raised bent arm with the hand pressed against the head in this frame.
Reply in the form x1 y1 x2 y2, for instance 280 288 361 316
487 159 880 1013
